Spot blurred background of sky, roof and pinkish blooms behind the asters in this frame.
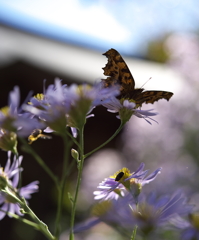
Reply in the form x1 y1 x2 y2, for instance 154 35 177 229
0 0 199 240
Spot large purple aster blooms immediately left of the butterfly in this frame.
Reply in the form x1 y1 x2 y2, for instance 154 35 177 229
24 79 119 135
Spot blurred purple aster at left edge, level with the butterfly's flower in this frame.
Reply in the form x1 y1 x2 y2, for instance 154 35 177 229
0 86 41 137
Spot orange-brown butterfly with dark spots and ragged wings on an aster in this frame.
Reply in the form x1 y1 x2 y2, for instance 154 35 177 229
102 48 173 107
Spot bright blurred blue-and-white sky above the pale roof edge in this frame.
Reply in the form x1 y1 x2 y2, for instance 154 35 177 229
0 0 199 55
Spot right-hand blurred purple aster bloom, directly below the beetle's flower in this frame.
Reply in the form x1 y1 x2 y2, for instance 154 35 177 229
131 191 192 234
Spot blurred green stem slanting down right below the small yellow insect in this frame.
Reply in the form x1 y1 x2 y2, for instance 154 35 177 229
20 138 59 187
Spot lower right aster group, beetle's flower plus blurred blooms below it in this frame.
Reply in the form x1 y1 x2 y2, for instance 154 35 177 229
75 163 193 239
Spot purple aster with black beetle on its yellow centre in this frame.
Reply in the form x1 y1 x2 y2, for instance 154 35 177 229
93 163 161 200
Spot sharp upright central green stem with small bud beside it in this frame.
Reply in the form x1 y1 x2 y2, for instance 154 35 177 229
70 127 85 240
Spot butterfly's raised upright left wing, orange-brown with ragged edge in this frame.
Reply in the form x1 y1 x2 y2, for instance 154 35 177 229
102 48 135 93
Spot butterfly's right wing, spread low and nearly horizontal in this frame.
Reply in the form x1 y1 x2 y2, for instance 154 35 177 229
134 91 173 106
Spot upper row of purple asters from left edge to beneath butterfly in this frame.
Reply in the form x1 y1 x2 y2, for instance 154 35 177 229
0 79 160 149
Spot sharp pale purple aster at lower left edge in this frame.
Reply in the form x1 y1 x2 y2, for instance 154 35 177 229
0 152 39 220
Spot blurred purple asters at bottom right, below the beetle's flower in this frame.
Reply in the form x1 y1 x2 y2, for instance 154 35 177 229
75 193 192 235
